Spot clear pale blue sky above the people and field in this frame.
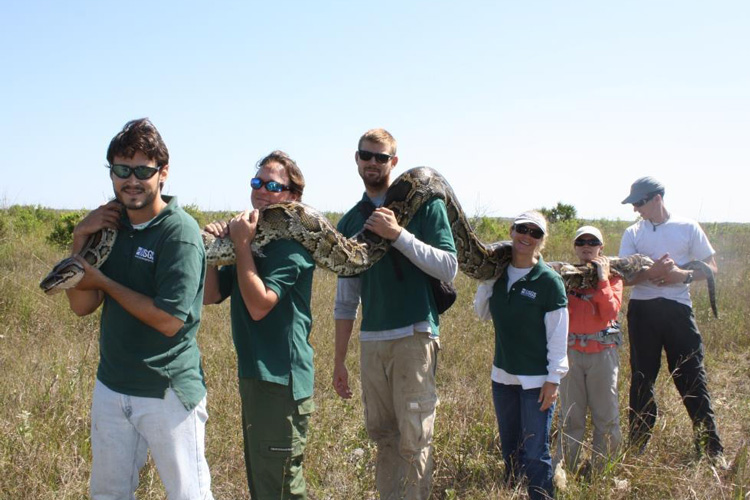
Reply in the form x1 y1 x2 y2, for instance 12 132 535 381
0 0 750 222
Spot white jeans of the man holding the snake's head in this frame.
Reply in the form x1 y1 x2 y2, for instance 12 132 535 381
91 380 213 500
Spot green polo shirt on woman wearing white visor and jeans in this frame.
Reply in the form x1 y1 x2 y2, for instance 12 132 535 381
490 257 568 375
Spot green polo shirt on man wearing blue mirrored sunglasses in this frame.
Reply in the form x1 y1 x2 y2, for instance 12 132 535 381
219 240 315 401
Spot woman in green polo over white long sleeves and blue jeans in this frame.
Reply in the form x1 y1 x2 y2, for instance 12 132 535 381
474 211 568 499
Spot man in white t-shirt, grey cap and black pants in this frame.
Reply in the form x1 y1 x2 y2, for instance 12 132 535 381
620 177 726 466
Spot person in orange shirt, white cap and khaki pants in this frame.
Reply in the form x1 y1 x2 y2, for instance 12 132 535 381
556 226 623 472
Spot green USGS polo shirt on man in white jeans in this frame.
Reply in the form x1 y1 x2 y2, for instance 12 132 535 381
97 196 206 410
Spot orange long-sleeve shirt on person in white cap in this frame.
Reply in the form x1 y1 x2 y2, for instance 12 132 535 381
568 275 623 354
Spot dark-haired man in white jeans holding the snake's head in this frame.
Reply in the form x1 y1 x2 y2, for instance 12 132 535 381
66 119 213 500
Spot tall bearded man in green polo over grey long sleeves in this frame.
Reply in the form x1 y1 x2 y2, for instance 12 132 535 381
333 129 458 500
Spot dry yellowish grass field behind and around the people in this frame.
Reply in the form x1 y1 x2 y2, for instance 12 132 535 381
0 207 750 500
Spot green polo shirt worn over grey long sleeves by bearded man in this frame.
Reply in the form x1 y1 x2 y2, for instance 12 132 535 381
338 194 456 336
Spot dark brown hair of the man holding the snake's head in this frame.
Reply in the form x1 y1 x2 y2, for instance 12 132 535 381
107 118 169 167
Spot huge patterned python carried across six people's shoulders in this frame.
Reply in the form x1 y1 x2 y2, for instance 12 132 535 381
40 167 715 316
